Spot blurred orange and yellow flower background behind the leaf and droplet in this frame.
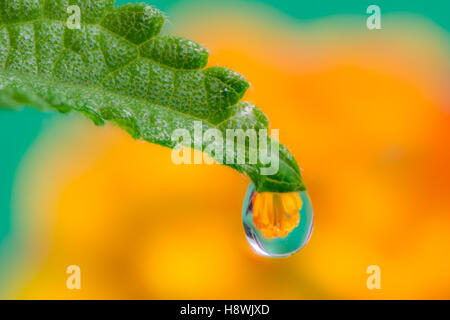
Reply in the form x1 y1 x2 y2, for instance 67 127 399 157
0 3 450 299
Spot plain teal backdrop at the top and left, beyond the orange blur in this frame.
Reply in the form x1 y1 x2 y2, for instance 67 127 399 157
0 0 450 246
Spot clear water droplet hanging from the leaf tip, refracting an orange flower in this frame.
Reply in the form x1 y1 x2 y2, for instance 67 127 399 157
242 183 313 257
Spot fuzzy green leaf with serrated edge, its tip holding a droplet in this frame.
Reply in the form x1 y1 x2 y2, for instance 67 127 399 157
0 0 304 192
